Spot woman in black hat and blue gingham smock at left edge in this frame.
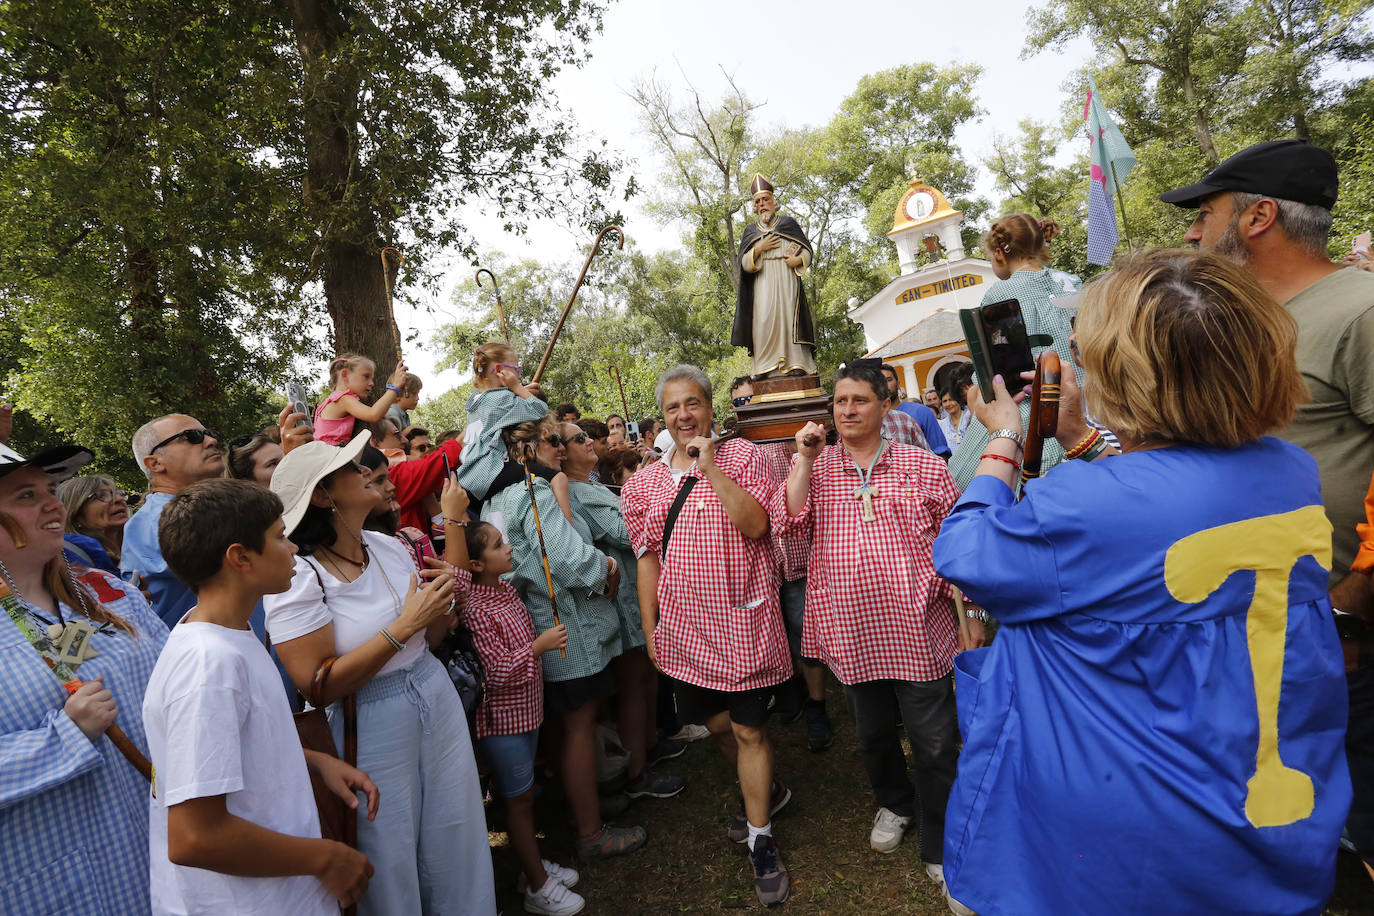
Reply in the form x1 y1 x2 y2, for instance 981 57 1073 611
0 445 168 913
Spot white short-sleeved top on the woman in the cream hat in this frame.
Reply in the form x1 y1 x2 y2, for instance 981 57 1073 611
262 531 426 676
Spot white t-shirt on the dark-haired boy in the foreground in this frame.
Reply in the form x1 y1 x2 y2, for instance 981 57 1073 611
143 619 338 916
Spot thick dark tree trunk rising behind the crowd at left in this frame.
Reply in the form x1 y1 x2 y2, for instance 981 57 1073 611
287 0 397 381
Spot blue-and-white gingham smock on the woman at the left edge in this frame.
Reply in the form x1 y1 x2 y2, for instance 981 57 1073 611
0 573 168 915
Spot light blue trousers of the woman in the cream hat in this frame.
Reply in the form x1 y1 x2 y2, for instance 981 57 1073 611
330 652 496 916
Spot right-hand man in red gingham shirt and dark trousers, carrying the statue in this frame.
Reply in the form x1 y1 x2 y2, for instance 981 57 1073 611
769 360 982 912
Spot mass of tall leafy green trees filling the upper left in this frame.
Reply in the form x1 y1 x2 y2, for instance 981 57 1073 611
0 0 617 480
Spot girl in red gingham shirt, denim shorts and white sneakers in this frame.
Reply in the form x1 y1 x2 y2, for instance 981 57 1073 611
464 522 585 915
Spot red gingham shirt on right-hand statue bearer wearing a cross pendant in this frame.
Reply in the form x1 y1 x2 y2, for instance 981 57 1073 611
768 441 959 684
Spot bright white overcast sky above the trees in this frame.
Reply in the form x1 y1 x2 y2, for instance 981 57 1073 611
396 0 1091 400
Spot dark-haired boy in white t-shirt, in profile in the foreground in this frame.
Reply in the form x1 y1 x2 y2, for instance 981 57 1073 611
143 479 378 916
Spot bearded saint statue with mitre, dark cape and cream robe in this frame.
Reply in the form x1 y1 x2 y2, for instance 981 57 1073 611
730 174 816 378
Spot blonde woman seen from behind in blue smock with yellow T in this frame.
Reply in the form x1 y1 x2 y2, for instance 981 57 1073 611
934 251 1351 916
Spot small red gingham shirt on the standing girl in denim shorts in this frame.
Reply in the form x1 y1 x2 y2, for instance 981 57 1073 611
463 582 544 737
